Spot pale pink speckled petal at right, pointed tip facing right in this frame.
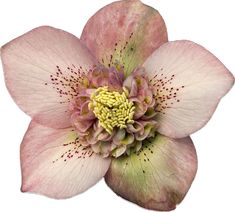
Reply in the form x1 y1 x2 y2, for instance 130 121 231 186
144 41 234 138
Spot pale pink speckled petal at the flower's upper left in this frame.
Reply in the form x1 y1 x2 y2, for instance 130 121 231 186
1 27 95 128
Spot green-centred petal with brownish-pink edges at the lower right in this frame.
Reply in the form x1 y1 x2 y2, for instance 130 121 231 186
105 135 197 211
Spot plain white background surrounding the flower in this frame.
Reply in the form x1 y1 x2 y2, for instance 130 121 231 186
0 0 235 212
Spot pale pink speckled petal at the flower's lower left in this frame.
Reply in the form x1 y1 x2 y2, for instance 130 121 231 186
21 122 110 199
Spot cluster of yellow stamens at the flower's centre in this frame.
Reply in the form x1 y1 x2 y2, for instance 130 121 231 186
89 86 135 134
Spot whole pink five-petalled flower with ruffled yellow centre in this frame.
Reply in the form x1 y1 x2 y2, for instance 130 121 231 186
1 0 234 210
